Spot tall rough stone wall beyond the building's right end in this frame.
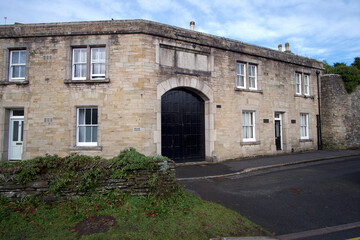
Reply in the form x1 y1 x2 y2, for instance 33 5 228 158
321 74 360 149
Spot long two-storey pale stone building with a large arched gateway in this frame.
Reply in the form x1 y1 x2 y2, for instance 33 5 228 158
0 20 322 162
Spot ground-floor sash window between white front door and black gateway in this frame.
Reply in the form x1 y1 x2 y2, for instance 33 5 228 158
76 107 98 146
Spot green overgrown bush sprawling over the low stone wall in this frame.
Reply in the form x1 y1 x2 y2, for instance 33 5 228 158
0 148 172 199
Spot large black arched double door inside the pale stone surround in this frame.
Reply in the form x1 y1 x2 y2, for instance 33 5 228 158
161 89 205 162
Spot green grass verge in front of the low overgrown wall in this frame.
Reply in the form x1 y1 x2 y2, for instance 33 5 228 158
0 190 270 239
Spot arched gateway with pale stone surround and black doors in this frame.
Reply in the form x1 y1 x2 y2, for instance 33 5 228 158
155 78 214 162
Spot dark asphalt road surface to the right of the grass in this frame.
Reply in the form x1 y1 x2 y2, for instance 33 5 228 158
181 156 360 235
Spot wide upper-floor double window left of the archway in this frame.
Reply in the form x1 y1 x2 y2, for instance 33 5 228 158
72 47 106 80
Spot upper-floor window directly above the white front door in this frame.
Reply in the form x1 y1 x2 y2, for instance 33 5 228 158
9 50 26 81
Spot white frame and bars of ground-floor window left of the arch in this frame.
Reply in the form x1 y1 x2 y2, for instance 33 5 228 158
76 107 99 146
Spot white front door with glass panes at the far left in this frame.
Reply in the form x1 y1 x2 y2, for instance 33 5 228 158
9 110 24 160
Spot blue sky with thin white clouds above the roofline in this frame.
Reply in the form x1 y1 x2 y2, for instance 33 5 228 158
0 0 360 64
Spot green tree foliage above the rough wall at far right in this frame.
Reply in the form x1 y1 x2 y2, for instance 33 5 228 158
324 57 360 93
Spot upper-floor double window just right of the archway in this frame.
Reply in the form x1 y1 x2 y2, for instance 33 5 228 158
236 62 257 90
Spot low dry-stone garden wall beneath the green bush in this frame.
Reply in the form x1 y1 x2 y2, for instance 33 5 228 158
0 158 176 201
